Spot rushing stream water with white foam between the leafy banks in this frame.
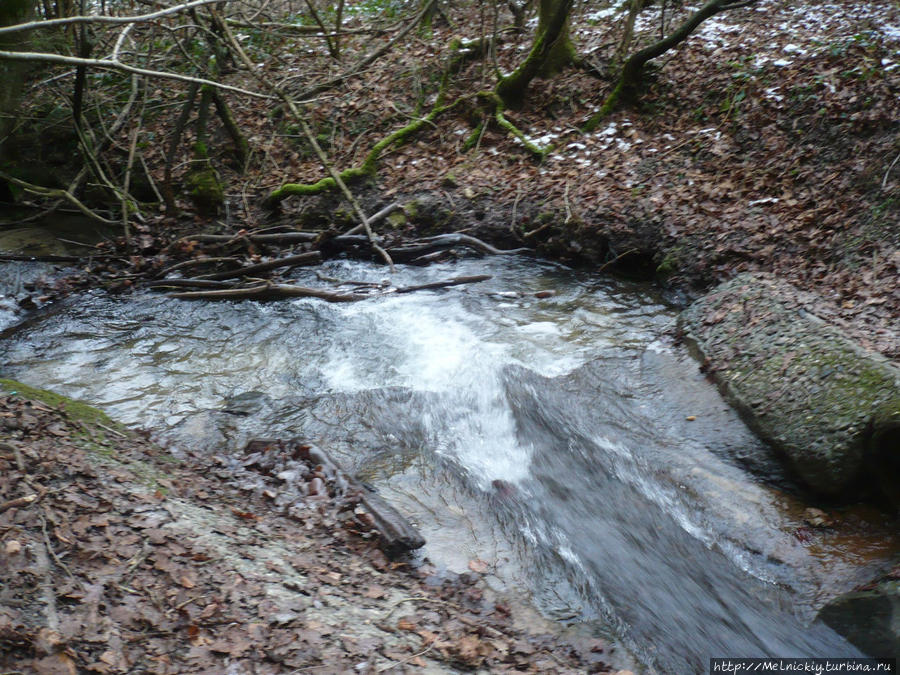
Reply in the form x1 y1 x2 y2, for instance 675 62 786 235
0 258 898 673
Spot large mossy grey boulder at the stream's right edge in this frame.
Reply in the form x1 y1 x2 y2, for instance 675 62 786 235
680 273 900 505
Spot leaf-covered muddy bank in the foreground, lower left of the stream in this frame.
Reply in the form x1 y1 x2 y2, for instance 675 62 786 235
0 381 624 673
